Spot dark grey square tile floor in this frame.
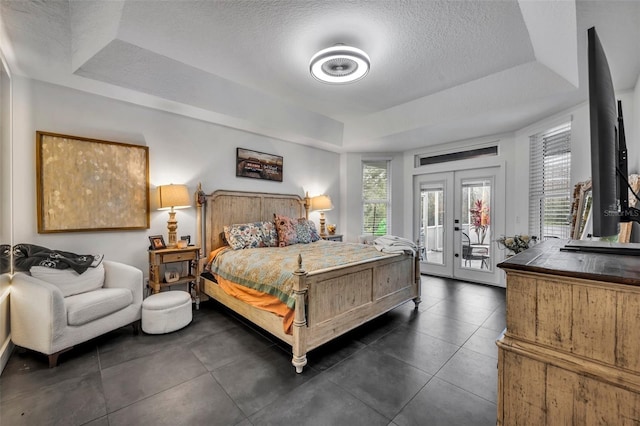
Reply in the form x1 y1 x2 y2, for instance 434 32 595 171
0 276 505 426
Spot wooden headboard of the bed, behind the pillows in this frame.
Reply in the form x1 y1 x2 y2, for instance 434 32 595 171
196 190 310 256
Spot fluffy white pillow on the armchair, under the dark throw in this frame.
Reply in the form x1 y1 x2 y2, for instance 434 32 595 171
29 263 104 297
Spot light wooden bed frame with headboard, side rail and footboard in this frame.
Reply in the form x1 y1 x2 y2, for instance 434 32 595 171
196 189 420 373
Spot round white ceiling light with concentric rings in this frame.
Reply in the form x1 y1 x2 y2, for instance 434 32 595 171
309 44 370 84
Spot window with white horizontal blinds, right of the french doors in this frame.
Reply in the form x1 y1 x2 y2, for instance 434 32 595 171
529 123 571 239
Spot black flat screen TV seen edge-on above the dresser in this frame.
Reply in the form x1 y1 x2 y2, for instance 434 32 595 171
587 27 640 241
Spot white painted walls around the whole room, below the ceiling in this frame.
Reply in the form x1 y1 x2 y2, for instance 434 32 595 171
7 77 640 274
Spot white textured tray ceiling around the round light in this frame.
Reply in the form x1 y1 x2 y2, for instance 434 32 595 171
0 0 640 151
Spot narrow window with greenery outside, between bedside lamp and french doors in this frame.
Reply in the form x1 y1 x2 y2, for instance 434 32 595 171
362 160 391 235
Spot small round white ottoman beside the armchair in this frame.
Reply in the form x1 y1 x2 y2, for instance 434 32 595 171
142 291 193 334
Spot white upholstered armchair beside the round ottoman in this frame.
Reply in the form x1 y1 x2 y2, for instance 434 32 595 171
10 260 143 367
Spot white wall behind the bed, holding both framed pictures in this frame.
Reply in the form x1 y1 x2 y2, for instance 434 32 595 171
13 78 341 276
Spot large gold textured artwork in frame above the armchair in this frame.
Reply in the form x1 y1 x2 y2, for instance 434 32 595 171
36 131 150 234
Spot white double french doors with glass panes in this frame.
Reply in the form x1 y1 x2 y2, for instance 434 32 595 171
415 166 504 286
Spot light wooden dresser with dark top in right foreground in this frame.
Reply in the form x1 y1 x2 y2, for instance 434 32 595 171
497 240 640 426
